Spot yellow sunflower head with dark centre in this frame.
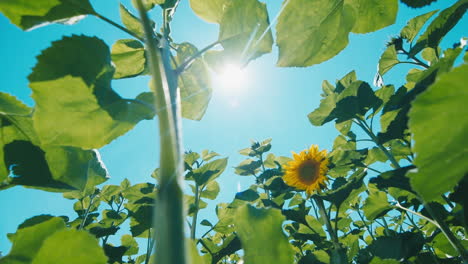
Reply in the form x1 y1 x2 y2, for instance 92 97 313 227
283 145 328 196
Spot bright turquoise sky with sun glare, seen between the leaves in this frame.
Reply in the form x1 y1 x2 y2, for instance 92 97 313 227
0 0 468 254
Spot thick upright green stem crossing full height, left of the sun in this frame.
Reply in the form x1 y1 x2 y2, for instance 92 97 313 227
136 0 189 264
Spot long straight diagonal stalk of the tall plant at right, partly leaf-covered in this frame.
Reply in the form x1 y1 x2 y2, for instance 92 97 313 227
354 119 468 263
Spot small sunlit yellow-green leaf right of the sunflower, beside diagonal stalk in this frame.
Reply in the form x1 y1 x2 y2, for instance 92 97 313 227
362 186 393 221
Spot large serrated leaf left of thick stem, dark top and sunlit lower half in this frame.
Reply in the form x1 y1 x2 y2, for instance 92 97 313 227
29 35 154 149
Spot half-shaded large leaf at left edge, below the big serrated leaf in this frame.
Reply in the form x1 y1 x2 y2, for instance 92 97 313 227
0 93 107 191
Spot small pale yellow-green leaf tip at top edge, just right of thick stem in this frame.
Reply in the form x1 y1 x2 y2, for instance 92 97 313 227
190 0 229 23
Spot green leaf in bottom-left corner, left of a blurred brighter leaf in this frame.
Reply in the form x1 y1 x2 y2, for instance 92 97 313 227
0 216 65 264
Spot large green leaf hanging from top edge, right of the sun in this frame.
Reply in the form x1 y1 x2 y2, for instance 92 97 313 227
276 0 355 67
